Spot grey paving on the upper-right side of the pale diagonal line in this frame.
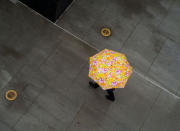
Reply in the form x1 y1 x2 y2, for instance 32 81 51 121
57 0 180 95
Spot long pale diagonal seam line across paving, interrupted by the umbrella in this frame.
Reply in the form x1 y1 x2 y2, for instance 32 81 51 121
18 1 180 99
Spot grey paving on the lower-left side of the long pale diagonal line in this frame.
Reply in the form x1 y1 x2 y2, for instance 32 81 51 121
0 0 180 131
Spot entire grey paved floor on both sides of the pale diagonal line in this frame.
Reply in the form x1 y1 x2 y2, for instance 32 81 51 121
0 0 180 131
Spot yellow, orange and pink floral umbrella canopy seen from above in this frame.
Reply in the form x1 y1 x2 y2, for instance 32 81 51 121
89 49 132 90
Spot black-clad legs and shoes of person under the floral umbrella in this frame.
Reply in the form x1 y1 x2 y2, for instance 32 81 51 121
89 81 115 101
